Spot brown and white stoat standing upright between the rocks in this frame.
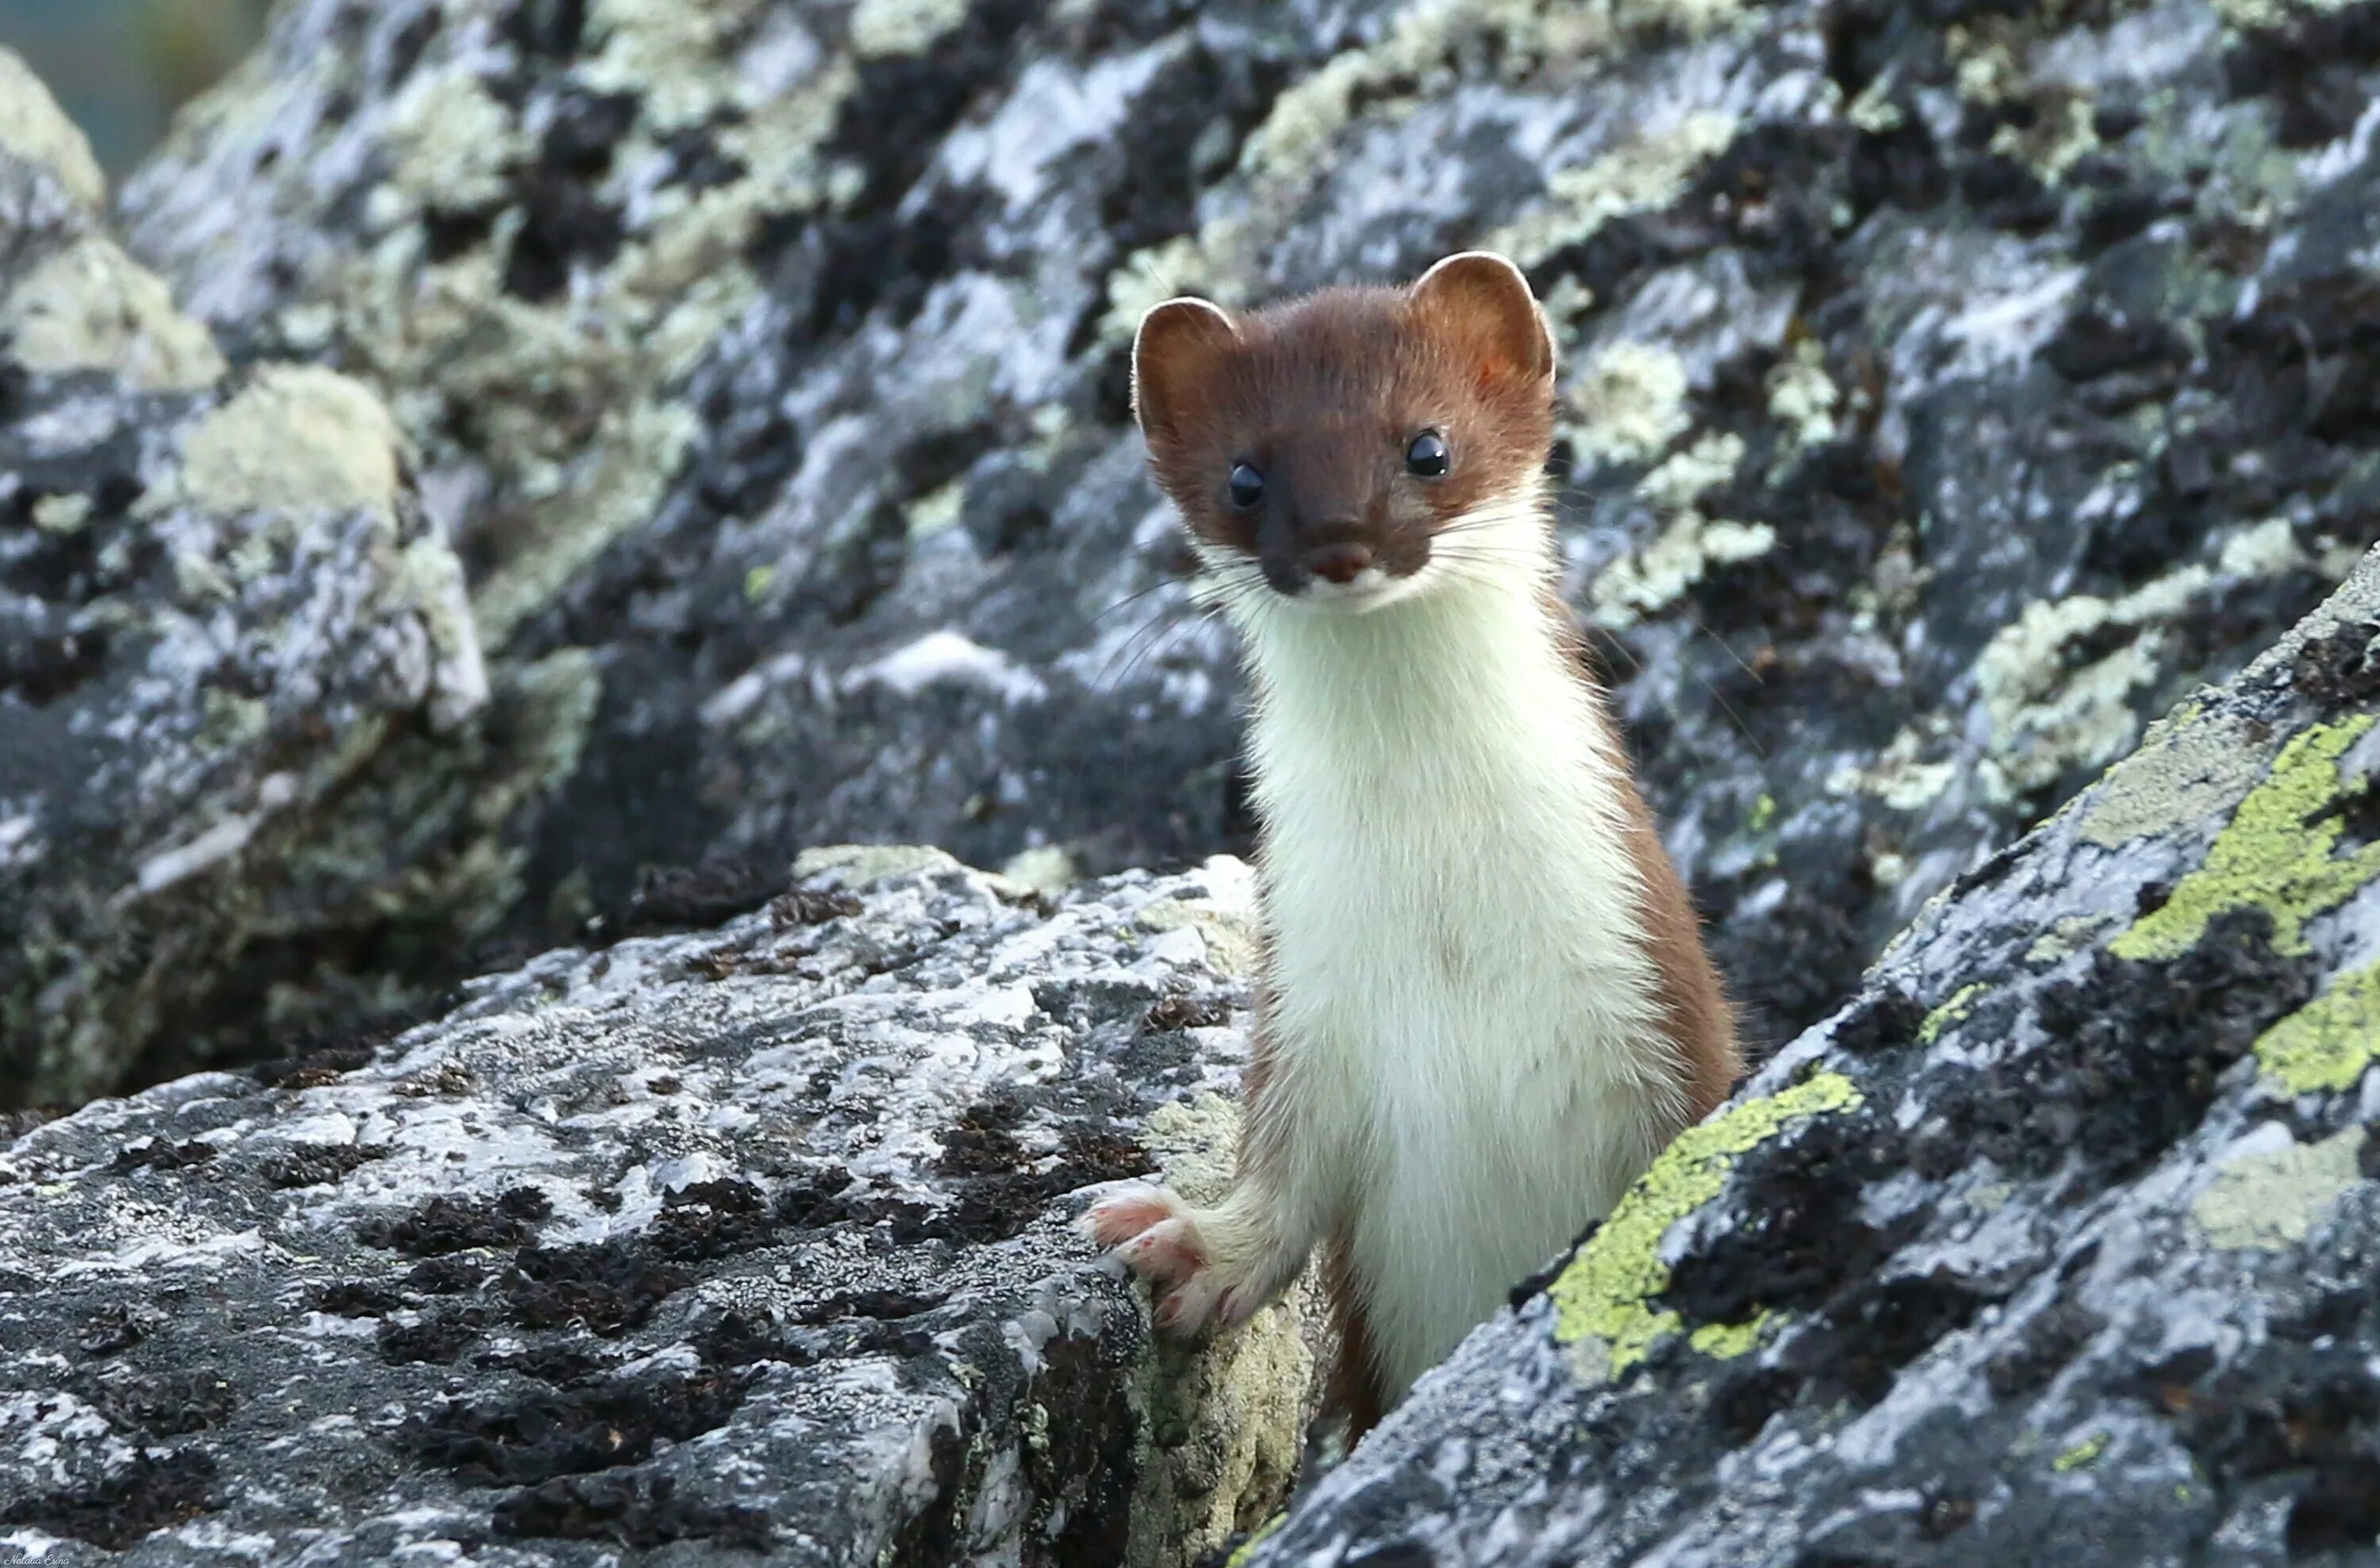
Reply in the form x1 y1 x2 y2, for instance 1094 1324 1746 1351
1085 252 1740 1432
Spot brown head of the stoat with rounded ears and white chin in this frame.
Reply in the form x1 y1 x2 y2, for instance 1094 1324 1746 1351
1133 250 1554 609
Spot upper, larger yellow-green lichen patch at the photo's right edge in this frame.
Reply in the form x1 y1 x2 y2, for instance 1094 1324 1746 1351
2109 714 2380 959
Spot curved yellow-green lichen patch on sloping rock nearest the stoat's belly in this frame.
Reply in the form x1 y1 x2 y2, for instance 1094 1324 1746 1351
1547 1070 1861 1378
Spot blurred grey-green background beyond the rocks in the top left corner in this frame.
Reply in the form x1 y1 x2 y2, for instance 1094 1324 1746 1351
0 0 271 179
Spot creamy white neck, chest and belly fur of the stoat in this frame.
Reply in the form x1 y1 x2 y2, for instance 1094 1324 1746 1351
1238 574 1680 1394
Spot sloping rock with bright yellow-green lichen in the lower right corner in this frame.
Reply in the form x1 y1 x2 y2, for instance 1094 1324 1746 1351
1250 552 2380 1568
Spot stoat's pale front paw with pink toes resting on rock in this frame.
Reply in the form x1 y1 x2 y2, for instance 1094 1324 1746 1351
1083 1185 1307 1337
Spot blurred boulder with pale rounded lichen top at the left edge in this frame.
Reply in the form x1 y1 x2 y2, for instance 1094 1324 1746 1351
0 55 488 1106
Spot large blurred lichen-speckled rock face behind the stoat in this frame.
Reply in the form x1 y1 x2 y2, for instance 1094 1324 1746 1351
112 0 2380 1061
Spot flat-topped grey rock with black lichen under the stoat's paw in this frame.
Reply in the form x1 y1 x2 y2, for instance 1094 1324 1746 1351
0 851 1311 1568
